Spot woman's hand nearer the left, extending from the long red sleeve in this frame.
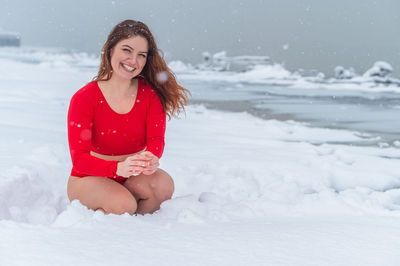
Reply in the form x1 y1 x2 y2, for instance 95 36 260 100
117 152 151 178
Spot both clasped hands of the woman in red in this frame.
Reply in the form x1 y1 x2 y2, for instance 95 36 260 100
117 151 160 177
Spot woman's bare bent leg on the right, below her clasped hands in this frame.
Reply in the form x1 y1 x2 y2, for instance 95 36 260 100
124 169 174 214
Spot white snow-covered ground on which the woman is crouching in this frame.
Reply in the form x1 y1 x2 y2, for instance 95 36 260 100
0 48 400 265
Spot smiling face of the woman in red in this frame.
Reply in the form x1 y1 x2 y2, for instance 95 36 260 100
111 36 149 79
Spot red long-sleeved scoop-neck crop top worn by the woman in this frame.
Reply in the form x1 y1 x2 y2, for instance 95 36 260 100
68 78 166 180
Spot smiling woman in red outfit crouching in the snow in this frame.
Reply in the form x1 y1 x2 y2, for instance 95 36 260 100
67 20 188 215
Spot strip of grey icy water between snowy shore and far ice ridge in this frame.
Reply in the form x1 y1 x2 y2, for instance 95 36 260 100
183 80 400 144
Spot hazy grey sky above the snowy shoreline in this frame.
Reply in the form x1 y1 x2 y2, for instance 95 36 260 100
0 0 400 76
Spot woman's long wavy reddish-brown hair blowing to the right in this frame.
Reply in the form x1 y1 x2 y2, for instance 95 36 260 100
93 20 190 118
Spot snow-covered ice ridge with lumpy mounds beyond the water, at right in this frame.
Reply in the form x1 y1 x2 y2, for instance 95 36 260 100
169 51 400 92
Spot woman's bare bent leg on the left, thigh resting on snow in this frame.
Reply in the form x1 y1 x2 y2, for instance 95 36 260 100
67 176 137 215
